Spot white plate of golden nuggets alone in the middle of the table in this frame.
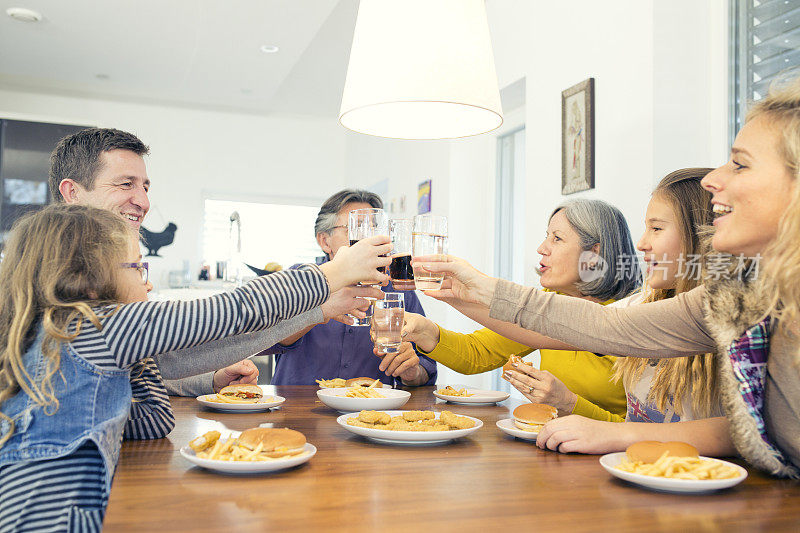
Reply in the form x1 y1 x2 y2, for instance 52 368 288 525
336 411 483 445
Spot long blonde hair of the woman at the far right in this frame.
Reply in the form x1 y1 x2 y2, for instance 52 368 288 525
747 75 800 334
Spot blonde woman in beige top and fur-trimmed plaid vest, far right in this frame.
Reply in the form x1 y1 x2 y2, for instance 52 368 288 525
415 78 800 478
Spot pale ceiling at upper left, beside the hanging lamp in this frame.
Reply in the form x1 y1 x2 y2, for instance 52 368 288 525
0 0 358 117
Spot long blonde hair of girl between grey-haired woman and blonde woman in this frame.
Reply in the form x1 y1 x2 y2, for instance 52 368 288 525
613 168 720 418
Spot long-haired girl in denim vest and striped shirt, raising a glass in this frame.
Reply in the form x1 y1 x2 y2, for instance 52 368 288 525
0 205 391 531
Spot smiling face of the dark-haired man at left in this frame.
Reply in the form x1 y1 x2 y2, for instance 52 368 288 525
65 149 150 230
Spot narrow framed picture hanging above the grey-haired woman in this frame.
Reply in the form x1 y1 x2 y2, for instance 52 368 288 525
561 78 594 194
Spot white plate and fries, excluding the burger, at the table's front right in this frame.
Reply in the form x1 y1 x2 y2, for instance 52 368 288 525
600 452 747 493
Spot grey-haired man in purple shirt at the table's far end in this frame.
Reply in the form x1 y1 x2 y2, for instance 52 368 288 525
272 189 436 386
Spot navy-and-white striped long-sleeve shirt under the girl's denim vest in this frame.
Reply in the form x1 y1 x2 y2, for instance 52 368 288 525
0 265 329 531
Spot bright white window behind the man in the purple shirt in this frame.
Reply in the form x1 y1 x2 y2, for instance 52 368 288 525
203 200 323 277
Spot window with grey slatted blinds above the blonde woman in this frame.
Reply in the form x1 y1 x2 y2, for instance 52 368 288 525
730 0 800 141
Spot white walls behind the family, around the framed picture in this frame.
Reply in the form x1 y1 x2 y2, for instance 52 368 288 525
0 0 728 386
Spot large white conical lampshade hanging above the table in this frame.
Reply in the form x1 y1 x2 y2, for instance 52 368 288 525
339 0 503 139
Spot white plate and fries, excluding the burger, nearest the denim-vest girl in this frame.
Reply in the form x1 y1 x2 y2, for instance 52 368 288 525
181 432 317 474
